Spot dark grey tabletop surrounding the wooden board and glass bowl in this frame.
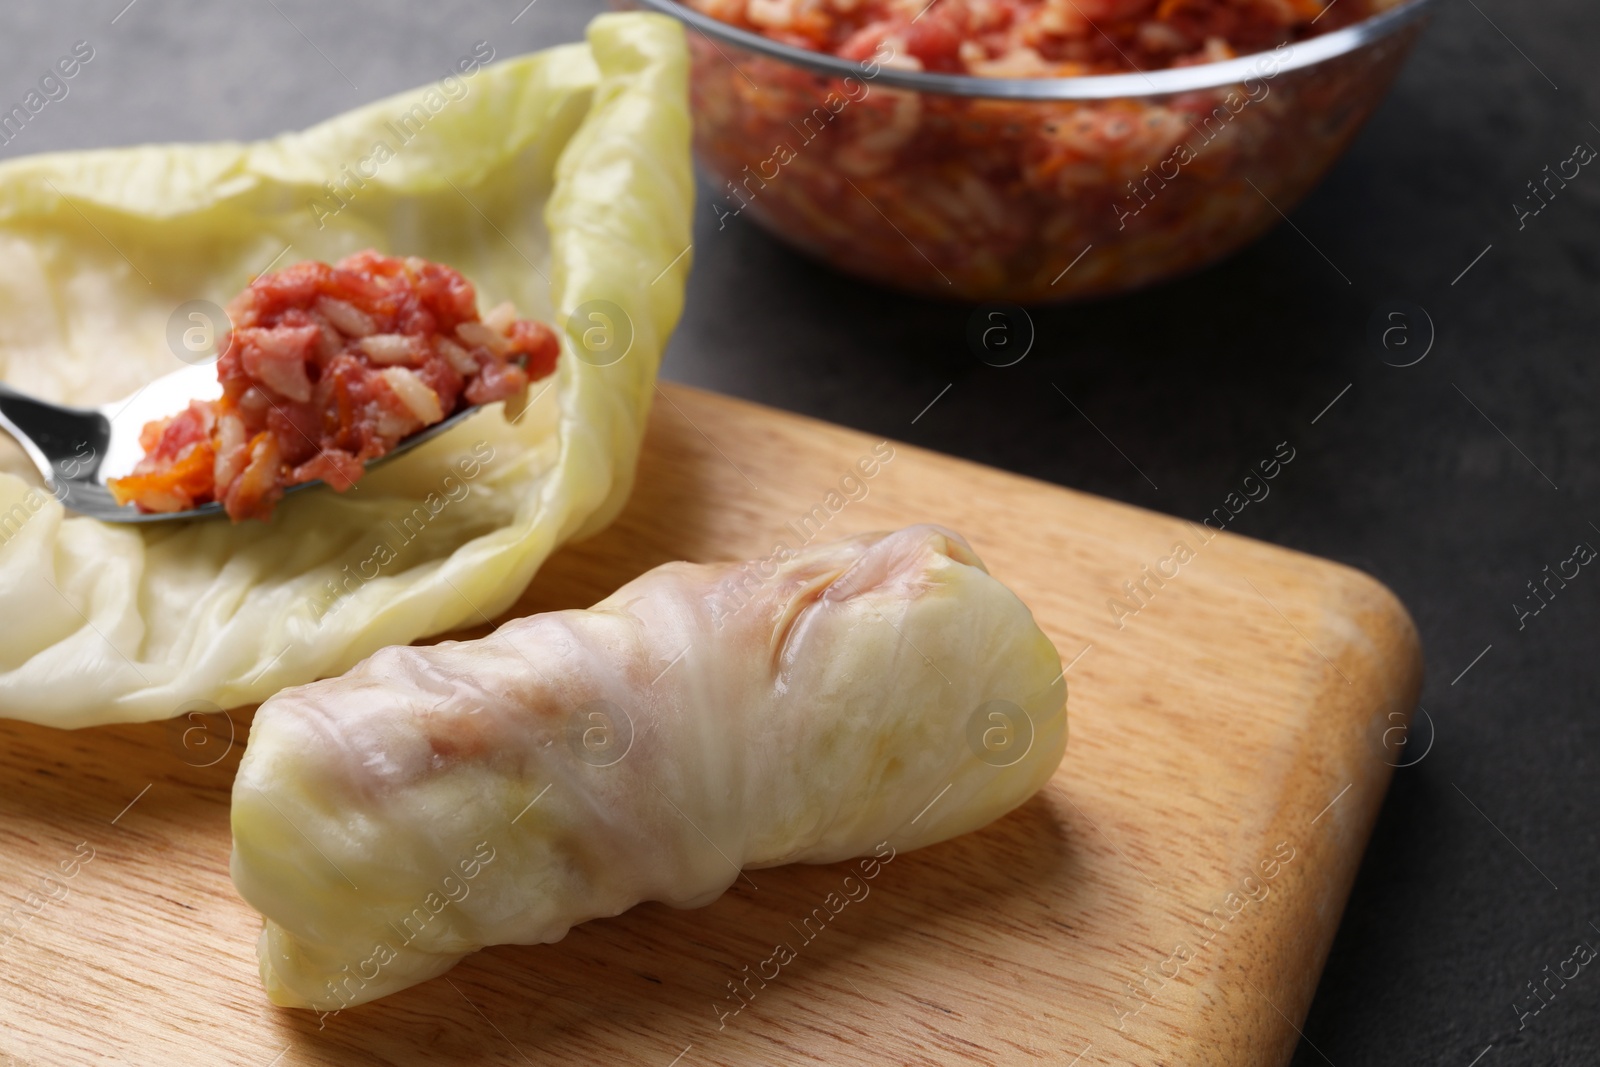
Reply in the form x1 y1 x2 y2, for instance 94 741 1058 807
0 0 1600 1067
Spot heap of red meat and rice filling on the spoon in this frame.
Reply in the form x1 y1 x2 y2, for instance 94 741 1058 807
110 251 560 522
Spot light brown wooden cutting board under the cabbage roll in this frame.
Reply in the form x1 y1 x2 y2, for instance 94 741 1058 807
0 386 1421 1067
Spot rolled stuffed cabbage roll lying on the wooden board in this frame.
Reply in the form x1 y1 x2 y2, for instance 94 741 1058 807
232 526 1066 1011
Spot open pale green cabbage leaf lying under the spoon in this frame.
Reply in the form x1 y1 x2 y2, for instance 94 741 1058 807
0 14 693 726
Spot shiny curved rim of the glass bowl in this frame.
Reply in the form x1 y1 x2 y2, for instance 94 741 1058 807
630 0 1434 101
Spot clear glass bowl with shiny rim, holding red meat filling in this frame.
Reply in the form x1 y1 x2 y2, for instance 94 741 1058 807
630 0 1432 304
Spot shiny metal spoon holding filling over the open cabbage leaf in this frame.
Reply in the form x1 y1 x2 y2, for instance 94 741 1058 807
0 363 478 523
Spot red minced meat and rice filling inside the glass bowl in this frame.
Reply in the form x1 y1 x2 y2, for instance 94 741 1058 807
683 0 1421 304
